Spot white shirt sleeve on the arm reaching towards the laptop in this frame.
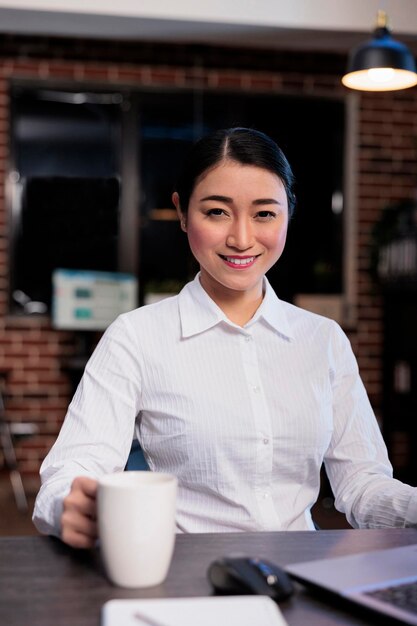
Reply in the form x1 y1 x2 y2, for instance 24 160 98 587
325 326 417 528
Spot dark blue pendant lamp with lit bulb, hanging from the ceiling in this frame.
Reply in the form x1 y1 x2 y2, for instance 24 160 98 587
342 11 417 91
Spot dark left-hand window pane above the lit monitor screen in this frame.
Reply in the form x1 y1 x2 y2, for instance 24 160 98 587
12 89 120 310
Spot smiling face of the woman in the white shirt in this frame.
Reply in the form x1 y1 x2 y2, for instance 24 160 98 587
173 160 288 298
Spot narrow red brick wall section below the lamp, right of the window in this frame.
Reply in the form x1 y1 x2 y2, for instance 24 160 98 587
354 89 417 402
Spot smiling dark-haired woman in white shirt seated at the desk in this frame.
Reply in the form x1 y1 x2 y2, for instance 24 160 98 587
34 128 417 547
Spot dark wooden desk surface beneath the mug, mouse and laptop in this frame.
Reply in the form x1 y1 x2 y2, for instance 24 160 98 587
0 529 417 626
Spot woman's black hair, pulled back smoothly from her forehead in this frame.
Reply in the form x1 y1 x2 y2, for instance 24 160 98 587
175 127 295 218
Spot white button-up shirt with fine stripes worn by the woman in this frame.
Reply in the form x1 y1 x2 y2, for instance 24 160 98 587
34 276 417 534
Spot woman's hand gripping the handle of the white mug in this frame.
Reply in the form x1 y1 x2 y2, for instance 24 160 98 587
61 476 97 548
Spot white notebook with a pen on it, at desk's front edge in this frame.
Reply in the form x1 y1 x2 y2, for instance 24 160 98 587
101 596 287 626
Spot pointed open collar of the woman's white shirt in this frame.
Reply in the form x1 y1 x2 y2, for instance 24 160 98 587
178 273 293 339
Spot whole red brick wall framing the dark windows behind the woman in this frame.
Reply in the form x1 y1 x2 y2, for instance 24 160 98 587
0 37 417 480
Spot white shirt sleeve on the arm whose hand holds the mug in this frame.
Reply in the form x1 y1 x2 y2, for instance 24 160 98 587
33 316 141 536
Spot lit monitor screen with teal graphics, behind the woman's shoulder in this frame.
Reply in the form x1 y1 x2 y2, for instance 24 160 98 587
52 269 138 330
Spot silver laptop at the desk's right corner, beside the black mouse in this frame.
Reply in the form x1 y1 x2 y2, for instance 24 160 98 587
285 544 417 624
